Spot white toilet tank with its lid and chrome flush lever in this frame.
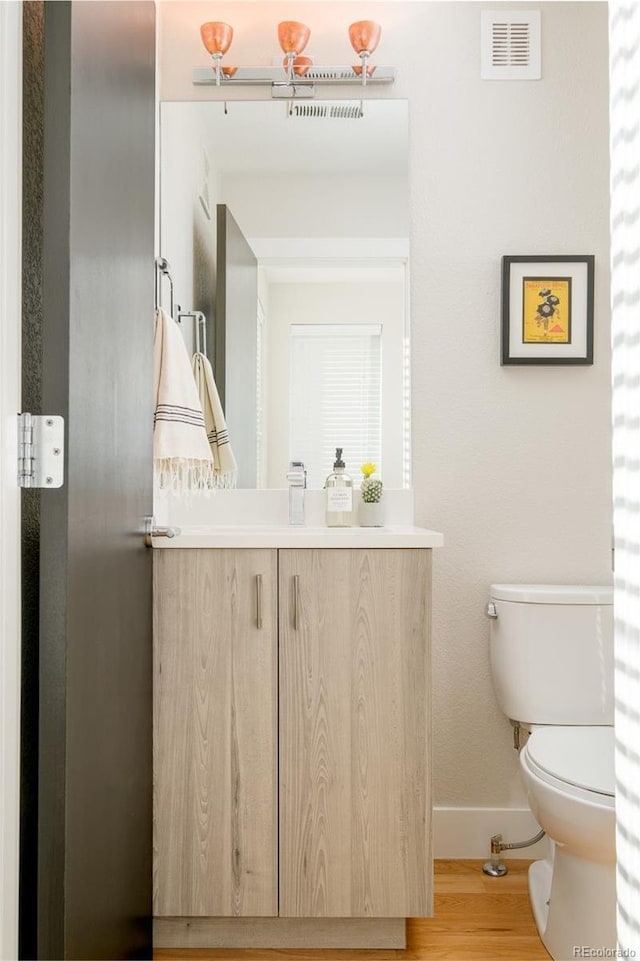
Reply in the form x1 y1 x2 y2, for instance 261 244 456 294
488 584 613 725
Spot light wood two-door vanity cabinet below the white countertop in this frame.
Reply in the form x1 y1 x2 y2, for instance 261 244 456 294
154 548 431 947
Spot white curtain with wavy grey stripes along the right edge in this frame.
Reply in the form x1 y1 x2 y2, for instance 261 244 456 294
609 0 640 958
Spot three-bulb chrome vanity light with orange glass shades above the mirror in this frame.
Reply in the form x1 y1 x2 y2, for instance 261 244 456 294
193 20 396 99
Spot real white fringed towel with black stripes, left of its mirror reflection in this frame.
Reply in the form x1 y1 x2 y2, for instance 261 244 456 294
153 309 213 491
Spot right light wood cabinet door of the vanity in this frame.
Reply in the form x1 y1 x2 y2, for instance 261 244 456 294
279 550 432 918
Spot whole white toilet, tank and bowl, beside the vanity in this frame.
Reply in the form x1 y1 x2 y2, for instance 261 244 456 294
487 584 616 961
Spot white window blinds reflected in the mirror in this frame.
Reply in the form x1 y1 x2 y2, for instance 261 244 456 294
289 324 382 488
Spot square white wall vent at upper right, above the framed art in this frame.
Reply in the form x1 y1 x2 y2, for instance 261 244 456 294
480 10 542 80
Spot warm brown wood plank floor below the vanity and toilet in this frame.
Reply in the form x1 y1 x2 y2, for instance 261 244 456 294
153 860 549 961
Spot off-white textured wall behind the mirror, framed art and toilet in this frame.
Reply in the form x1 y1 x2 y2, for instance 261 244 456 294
159 0 611 820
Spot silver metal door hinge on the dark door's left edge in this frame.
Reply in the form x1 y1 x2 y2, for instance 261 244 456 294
18 414 64 487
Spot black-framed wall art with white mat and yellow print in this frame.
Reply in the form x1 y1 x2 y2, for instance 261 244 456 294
501 255 594 365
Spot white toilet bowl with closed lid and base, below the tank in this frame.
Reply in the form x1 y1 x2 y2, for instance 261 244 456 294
520 727 616 961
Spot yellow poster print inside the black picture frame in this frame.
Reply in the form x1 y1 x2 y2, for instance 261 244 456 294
522 277 571 344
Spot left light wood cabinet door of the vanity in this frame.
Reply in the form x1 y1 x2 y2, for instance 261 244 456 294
153 549 278 917
